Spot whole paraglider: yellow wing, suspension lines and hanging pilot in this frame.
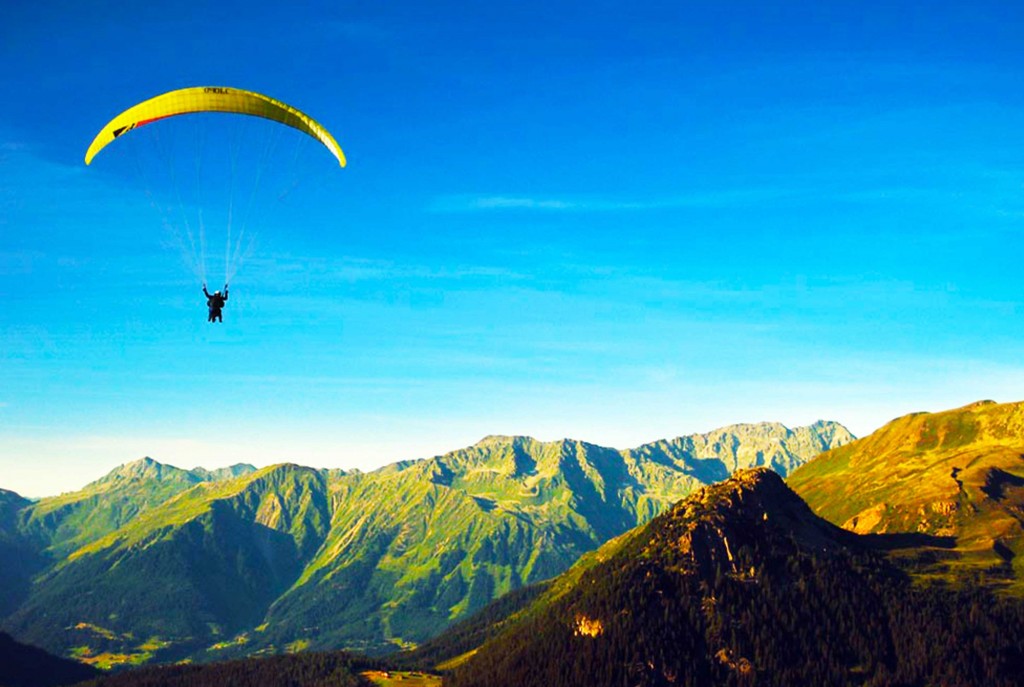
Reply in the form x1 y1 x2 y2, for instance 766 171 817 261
85 86 346 323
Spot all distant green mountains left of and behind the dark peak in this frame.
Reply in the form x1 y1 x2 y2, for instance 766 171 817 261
0 422 853 664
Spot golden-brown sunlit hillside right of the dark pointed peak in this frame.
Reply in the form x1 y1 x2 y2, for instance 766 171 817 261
788 401 1024 595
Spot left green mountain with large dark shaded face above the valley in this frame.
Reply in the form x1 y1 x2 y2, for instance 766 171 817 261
5 465 330 662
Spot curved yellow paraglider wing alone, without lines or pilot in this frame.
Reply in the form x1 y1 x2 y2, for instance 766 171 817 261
85 86 345 167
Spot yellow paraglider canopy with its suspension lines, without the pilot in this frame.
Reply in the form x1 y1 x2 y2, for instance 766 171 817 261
85 86 345 296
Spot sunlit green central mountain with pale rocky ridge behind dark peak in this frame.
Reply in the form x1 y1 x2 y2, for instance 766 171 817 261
246 423 852 652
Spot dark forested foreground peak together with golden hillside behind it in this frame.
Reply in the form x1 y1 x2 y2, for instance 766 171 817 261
398 401 1024 687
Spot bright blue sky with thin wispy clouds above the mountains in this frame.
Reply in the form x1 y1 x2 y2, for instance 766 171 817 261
0 0 1024 496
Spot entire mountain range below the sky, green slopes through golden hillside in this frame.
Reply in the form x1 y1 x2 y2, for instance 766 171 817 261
6 401 1024 687
